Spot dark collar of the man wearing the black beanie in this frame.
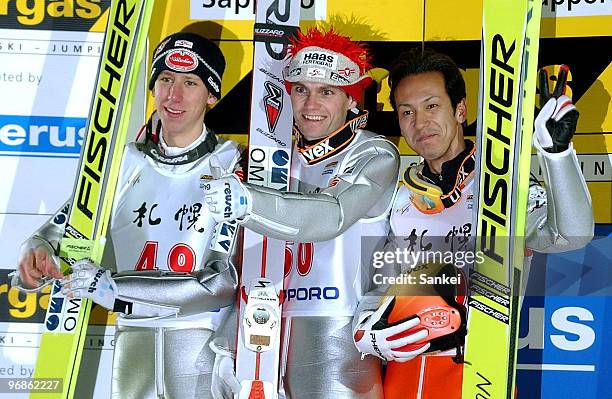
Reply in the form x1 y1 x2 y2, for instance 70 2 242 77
136 113 218 165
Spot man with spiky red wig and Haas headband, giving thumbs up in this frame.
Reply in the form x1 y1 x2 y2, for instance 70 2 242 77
206 29 399 399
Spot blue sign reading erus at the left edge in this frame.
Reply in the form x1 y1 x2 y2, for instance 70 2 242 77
0 115 87 158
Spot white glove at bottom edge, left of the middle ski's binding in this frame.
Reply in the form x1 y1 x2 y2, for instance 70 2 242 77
208 337 240 399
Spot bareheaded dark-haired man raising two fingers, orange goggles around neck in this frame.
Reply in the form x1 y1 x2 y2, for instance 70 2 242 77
354 48 594 399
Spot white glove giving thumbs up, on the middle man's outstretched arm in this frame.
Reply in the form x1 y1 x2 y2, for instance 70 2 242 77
200 174 251 222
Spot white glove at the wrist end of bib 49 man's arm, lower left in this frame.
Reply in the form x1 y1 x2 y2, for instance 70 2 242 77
62 259 118 310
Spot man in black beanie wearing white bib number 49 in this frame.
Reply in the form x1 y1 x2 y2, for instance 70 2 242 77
12 32 240 399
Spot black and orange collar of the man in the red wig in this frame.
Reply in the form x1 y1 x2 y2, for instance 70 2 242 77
293 108 368 165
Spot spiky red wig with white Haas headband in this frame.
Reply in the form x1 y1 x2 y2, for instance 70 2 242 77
285 28 372 101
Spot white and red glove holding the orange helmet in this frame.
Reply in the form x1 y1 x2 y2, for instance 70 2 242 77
353 297 430 363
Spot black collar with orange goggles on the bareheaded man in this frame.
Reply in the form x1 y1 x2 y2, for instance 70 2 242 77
401 140 476 214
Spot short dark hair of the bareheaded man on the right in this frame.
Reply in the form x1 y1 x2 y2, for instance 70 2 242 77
389 47 465 110
